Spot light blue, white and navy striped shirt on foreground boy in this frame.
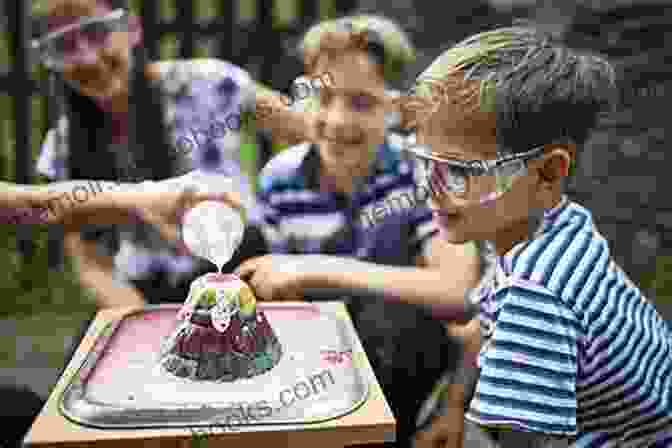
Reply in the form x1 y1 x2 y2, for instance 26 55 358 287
467 198 672 448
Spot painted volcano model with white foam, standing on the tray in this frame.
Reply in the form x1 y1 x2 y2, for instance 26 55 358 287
160 273 282 381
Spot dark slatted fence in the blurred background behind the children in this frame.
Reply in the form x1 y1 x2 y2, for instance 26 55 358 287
0 0 357 267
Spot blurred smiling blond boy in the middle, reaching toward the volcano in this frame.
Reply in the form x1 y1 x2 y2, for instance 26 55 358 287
241 16 478 448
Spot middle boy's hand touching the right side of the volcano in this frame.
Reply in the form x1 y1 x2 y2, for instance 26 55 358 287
236 255 311 300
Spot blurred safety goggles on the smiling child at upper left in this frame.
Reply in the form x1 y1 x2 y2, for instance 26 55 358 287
31 9 128 70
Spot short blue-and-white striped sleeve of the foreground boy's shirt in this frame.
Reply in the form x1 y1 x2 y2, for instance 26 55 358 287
467 285 579 435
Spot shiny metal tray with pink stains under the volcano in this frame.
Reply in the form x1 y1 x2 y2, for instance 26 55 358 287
59 303 369 430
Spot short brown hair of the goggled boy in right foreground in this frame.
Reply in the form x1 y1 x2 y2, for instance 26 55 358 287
401 25 616 153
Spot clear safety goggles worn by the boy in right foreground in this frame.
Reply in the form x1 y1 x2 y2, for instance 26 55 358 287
405 144 544 204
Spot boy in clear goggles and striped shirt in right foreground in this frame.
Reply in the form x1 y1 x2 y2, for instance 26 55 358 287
403 27 672 448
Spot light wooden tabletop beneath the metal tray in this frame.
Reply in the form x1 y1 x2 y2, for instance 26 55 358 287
24 302 396 448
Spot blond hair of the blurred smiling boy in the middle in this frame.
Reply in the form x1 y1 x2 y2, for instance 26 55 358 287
299 15 415 82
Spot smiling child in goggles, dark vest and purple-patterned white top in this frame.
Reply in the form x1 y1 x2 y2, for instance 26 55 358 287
31 0 305 307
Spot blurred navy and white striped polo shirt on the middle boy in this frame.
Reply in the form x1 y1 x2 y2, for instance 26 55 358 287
252 135 437 258
